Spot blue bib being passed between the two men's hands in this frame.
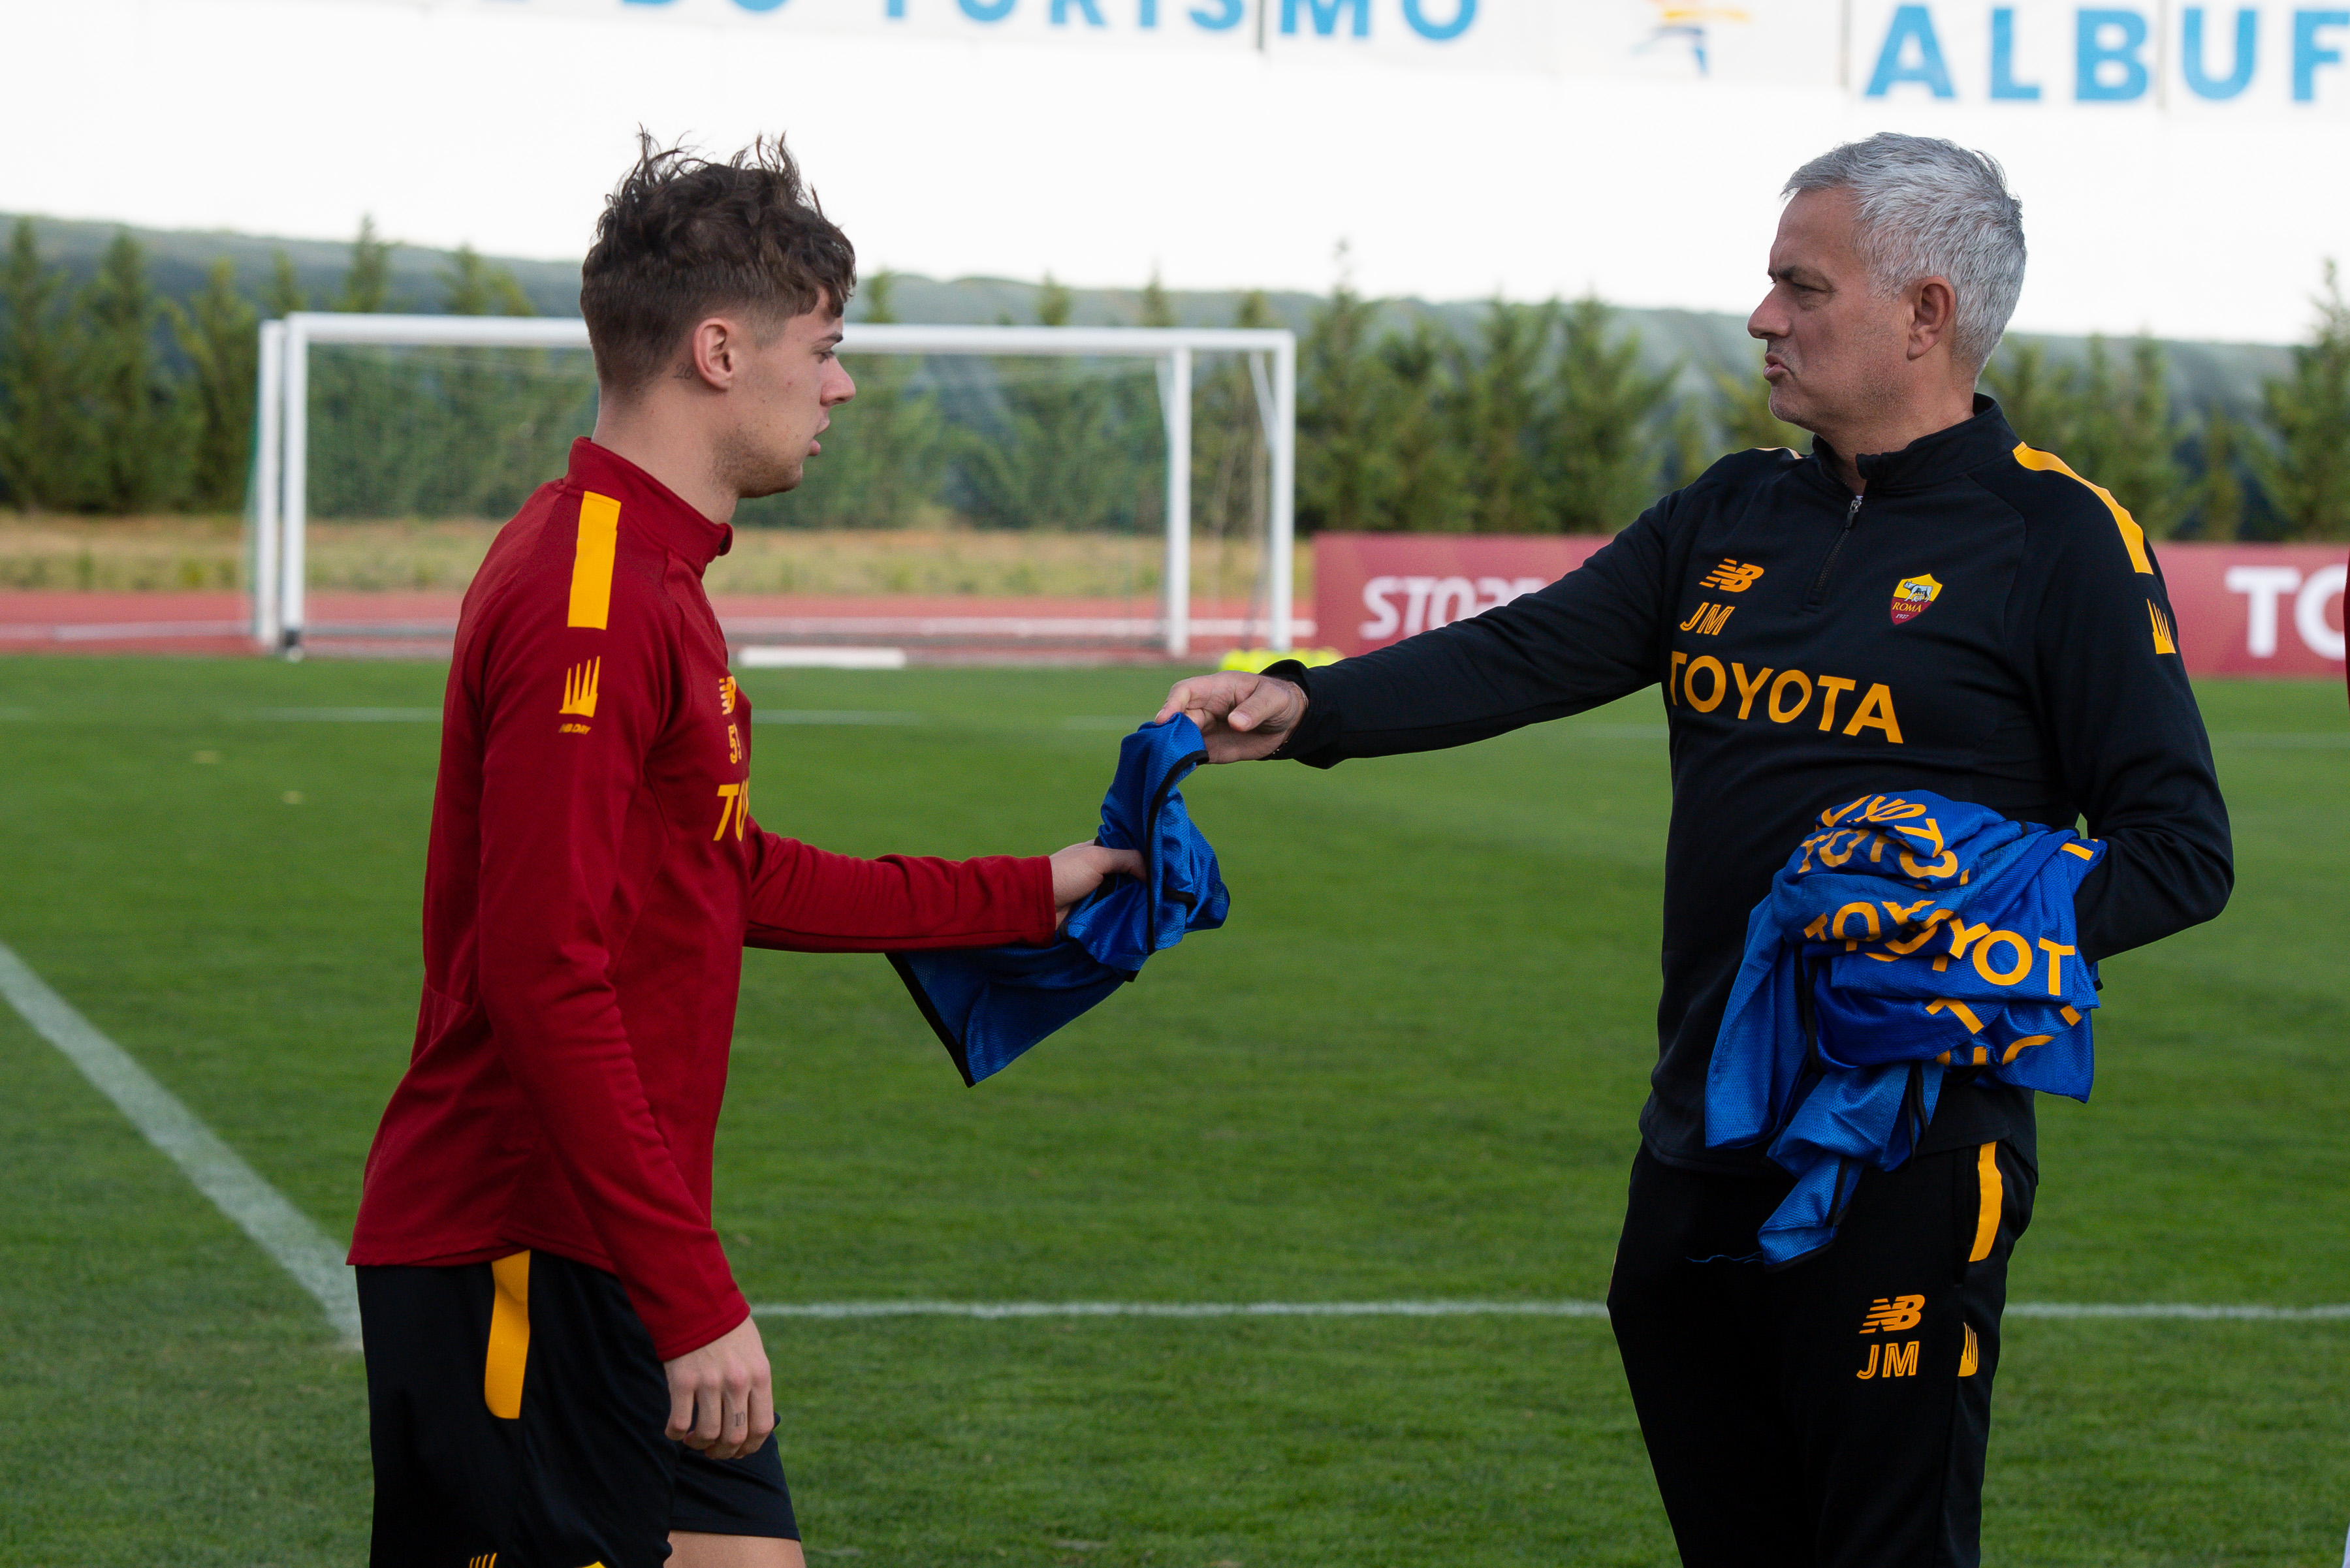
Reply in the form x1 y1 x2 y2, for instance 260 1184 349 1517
888 715 1231 1084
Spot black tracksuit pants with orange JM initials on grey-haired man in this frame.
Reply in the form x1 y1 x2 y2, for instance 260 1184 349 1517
1608 1142 2035 1568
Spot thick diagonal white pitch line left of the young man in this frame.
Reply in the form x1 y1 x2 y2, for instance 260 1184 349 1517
0 943 360 1345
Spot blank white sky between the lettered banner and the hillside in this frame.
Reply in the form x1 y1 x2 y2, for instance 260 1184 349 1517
0 0 2350 341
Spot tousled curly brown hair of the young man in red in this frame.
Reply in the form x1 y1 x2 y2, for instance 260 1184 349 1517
580 132 858 398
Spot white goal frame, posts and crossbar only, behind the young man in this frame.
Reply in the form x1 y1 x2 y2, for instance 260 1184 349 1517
251 310 1297 658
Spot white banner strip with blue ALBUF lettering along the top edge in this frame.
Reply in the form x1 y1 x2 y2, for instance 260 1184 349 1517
298 0 2350 113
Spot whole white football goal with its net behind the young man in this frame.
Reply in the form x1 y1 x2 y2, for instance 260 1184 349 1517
249 313 1297 658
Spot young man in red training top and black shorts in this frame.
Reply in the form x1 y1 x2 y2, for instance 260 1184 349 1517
350 141 1142 1568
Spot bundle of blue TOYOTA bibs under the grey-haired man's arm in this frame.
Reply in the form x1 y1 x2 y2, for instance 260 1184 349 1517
1706 790 2106 1267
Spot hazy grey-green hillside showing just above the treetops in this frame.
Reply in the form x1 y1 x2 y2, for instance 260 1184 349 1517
0 214 2291 416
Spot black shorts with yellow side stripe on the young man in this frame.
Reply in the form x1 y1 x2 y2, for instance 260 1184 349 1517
360 1253 799 1568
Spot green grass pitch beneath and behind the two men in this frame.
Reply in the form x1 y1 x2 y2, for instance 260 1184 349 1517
0 658 2350 1568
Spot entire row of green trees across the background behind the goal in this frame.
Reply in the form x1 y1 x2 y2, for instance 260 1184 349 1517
14 221 2350 541
